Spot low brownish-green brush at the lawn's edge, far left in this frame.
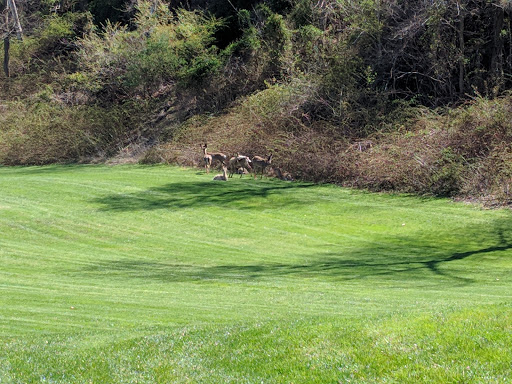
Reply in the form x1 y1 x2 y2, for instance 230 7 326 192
0 94 143 165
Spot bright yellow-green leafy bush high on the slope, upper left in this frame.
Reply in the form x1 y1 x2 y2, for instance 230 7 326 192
75 1 221 99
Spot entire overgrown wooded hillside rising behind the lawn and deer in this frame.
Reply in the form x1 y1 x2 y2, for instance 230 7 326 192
0 0 512 205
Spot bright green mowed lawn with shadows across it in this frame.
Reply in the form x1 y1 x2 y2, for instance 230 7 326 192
0 165 512 384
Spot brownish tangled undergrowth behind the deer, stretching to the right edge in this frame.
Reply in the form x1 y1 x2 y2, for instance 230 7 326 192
155 91 512 205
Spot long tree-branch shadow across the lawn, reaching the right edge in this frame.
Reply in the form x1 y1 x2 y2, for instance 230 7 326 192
85 221 512 285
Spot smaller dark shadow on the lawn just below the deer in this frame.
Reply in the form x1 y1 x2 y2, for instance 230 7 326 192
93 181 313 211
